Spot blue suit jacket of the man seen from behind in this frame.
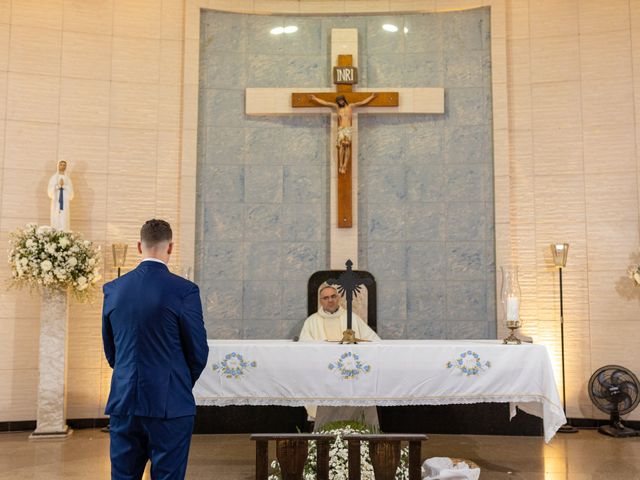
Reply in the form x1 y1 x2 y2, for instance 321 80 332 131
102 261 209 418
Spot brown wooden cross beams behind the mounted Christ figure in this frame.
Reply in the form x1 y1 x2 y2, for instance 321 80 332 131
291 55 398 228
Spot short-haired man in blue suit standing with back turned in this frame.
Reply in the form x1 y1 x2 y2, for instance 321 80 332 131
102 220 209 480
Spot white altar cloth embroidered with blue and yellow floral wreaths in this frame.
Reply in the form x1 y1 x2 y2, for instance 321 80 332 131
193 340 566 442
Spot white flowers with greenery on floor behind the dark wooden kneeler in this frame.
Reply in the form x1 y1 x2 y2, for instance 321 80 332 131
269 422 409 480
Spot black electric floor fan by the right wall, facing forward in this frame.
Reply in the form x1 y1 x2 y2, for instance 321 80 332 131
589 365 640 437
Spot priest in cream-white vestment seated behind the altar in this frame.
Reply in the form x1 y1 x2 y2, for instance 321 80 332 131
300 283 380 431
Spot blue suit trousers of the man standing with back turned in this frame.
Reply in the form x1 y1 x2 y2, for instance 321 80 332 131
109 415 194 480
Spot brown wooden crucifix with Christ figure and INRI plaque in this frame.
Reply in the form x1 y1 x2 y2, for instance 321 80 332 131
291 55 398 228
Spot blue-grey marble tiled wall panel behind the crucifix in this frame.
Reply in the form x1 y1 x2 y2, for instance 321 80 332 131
195 9 495 338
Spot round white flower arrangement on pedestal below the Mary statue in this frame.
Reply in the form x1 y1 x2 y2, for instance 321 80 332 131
9 223 102 300
